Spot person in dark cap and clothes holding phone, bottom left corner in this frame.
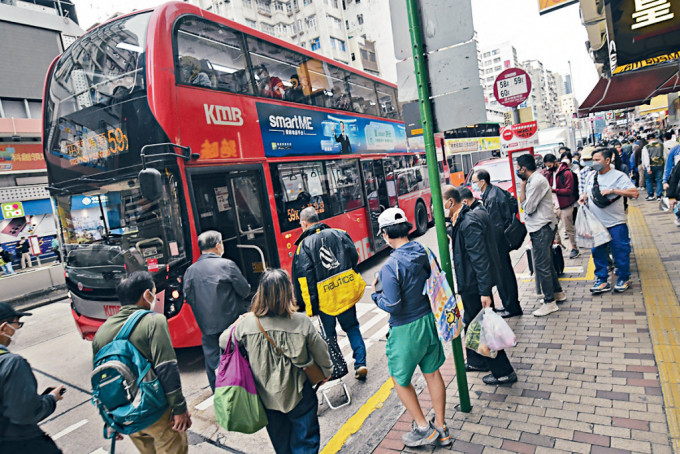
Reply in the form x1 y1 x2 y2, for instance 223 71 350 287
0 303 65 454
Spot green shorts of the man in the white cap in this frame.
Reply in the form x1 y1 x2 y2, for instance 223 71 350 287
385 314 446 386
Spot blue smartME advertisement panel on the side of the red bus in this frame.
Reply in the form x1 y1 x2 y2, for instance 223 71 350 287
257 103 407 157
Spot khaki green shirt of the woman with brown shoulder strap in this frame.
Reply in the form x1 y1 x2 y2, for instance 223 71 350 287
220 312 333 413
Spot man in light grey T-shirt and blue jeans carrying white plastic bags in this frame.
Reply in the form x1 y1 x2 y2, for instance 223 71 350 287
577 148 639 295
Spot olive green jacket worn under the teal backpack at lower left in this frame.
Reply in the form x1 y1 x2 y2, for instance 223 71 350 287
92 306 187 415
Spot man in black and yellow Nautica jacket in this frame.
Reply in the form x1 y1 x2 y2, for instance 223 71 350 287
293 207 368 380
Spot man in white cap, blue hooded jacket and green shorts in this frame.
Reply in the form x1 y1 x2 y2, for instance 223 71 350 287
371 208 453 447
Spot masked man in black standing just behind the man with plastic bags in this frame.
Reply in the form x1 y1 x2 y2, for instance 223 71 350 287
472 169 522 318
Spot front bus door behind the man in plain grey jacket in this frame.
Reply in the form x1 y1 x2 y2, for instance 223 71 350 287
187 169 278 291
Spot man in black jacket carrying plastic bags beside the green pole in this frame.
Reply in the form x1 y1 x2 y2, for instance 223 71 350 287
443 186 517 385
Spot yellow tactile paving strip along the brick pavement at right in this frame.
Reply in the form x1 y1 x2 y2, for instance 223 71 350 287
628 206 680 448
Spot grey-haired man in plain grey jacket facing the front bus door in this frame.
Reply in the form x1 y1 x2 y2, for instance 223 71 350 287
184 230 250 392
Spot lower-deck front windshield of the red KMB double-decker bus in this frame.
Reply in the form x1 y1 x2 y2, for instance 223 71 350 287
55 173 186 272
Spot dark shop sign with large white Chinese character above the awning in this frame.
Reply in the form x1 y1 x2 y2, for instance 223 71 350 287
605 0 680 74
